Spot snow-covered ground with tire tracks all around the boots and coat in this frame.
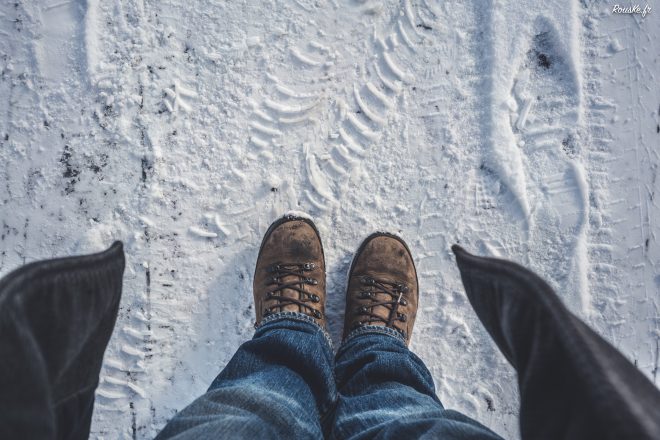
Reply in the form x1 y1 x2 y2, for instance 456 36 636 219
0 0 660 439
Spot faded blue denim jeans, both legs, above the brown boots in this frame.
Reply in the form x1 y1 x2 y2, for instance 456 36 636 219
156 312 500 440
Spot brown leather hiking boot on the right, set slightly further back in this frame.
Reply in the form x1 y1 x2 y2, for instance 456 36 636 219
344 232 419 344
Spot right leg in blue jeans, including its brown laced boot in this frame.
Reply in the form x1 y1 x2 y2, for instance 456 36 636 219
326 237 499 439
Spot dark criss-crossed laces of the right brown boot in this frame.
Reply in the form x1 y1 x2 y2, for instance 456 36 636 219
354 276 410 331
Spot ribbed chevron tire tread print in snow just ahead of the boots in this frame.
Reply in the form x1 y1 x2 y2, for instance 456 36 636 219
241 1 417 212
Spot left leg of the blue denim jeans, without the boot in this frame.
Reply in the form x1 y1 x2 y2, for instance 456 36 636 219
157 312 336 439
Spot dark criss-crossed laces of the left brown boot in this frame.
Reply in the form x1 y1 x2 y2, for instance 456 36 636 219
264 263 323 319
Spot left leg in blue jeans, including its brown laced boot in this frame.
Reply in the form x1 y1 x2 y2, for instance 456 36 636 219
158 216 336 439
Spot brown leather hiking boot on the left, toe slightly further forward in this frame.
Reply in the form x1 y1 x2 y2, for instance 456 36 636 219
253 215 326 328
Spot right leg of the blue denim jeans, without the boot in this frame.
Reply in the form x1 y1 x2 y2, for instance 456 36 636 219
330 326 499 439
